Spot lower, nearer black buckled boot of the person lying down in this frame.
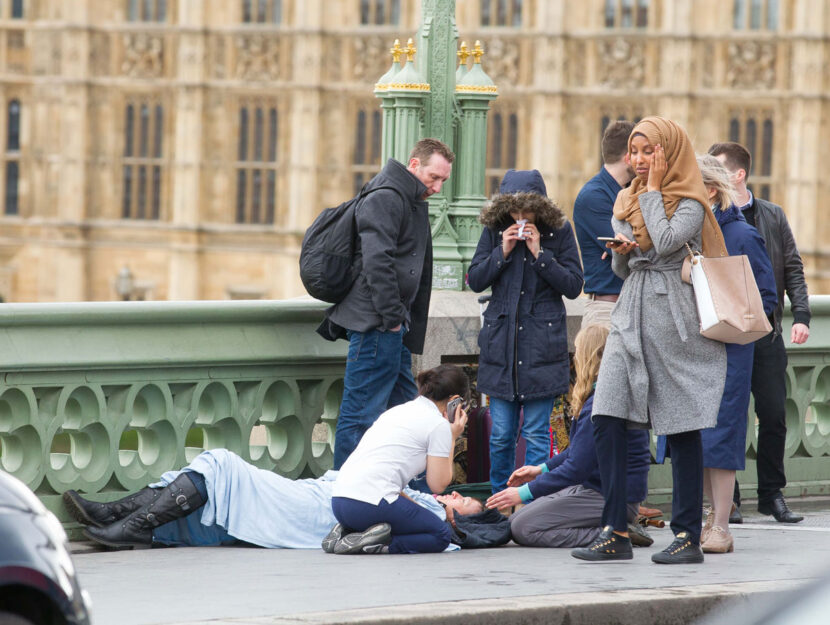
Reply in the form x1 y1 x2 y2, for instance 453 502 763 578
84 473 205 549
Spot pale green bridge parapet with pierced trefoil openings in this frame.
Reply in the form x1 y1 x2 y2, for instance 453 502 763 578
0 296 830 531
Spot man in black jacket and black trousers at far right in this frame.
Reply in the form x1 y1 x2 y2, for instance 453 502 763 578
709 142 810 523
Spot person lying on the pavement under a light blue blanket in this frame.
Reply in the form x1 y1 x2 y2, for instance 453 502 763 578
63 449 482 549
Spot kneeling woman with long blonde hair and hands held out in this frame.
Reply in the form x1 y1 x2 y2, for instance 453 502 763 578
486 324 651 547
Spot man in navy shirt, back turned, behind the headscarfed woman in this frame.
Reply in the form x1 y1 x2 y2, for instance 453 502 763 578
574 121 634 327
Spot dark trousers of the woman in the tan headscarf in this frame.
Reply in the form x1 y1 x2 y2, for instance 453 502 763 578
593 415 703 544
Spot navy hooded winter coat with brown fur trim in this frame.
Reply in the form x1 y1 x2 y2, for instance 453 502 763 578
467 170 582 401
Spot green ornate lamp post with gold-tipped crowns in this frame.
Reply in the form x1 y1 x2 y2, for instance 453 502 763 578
375 0 497 291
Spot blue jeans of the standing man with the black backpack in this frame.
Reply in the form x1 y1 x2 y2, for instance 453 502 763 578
334 328 418 470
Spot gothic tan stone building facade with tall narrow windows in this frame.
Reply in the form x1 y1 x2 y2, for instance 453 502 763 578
0 0 830 301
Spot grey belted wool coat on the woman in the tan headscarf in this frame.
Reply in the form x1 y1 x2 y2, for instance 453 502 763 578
592 191 726 434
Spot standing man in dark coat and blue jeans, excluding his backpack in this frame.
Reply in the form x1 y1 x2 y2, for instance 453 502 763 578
320 139 455 469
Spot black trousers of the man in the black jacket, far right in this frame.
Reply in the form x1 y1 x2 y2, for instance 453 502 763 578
735 334 787 505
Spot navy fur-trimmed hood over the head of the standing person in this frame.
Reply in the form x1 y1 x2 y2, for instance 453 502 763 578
478 169 565 230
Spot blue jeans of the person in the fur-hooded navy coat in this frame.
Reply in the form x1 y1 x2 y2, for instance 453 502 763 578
490 397 556 493
